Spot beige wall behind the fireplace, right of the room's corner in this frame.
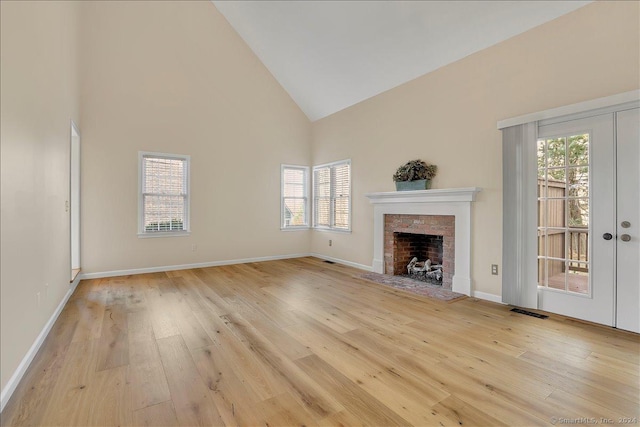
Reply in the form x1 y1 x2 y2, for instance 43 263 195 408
312 2 640 295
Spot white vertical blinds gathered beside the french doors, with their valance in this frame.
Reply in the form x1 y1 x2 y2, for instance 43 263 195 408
498 96 640 318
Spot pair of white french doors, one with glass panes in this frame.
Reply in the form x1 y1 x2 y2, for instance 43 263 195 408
537 108 640 332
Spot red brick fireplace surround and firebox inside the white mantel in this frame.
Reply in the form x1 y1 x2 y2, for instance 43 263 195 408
384 214 455 289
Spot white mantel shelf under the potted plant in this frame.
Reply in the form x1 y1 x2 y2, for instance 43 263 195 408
365 187 482 204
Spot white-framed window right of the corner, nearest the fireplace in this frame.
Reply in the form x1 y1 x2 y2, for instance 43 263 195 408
313 160 351 231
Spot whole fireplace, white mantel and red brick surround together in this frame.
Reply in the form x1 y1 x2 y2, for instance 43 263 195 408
366 187 481 295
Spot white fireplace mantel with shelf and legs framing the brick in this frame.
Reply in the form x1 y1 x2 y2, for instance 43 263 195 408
365 187 482 295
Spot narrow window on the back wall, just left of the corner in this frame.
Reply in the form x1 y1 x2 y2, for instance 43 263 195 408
280 165 309 230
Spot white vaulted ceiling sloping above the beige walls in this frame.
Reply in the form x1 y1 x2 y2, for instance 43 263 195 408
213 0 590 121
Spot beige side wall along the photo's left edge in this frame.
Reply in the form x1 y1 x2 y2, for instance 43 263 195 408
0 1 78 389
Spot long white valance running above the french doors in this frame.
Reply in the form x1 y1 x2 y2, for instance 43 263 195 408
498 89 640 130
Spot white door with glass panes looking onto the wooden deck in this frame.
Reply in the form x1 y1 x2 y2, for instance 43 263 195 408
538 114 616 326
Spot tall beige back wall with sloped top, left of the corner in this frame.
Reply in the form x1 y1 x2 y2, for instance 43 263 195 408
81 1 311 273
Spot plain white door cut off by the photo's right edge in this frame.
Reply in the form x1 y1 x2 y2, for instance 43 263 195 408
615 108 640 332
